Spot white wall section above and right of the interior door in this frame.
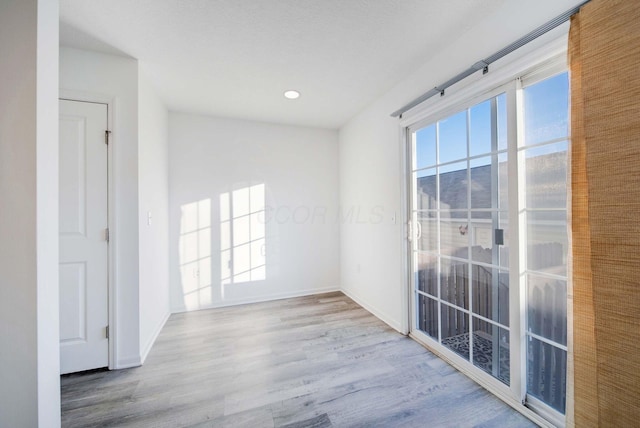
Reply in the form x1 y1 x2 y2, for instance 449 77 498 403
60 47 141 368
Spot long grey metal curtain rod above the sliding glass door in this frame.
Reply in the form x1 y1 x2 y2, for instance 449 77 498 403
391 0 590 117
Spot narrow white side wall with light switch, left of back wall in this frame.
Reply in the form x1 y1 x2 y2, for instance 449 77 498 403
138 70 170 362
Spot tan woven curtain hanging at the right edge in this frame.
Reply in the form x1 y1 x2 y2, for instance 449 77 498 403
567 0 640 427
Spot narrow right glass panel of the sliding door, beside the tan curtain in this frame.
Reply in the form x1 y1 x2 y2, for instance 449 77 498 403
519 73 569 413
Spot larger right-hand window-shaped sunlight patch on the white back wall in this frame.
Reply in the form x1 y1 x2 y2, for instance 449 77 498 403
220 184 267 286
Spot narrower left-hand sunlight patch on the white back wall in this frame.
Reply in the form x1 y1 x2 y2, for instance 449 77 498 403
179 199 213 310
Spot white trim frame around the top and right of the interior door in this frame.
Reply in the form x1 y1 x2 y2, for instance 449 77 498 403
58 89 118 370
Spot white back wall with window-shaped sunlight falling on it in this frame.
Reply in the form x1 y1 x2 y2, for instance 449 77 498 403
169 112 339 311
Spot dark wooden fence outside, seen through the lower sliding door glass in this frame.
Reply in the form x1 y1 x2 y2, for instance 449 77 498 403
417 243 567 412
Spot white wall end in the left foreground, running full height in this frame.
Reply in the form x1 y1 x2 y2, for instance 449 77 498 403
0 0 60 427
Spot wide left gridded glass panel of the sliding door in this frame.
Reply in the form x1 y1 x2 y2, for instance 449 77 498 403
411 94 510 385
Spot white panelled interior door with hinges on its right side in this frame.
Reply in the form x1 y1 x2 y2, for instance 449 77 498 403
59 100 109 374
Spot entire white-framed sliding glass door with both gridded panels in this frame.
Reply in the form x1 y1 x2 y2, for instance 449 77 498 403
407 69 568 417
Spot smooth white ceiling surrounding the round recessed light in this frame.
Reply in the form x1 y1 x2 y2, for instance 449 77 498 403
60 0 506 128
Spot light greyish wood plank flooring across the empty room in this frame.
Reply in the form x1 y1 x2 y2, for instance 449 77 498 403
61 293 535 428
